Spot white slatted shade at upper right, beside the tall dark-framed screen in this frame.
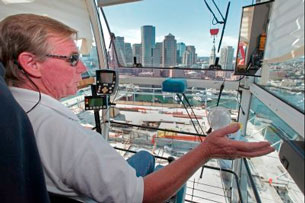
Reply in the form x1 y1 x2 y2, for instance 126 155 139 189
264 0 304 63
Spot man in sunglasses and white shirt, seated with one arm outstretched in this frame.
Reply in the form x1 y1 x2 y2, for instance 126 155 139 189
0 14 273 203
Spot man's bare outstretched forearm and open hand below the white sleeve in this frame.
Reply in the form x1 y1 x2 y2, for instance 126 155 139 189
143 123 274 203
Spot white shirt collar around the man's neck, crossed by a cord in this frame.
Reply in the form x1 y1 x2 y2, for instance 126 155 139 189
10 87 79 121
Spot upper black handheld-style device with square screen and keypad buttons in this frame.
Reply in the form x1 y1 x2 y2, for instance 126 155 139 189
96 69 119 95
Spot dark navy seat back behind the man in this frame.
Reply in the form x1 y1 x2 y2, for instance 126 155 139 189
0 62 49 203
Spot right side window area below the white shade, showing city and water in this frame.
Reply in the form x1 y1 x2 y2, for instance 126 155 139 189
258 57 304 112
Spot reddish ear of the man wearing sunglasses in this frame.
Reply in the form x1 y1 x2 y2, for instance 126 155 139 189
18 52 41 78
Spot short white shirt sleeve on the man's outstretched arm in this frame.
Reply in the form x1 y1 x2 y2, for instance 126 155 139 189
33 112 144 203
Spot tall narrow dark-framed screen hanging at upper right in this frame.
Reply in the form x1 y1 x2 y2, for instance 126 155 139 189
234 1 273 75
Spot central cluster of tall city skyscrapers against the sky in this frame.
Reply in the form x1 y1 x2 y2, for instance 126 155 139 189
114 25 197 67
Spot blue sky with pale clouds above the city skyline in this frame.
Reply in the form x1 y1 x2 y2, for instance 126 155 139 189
104 0 253 56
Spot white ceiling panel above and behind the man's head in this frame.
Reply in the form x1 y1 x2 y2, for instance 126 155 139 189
0 0 93 48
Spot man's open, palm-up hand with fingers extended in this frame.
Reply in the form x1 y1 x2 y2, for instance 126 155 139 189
202 123 274 159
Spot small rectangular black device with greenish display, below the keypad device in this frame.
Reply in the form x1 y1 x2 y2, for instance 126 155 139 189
85 96 109 110
